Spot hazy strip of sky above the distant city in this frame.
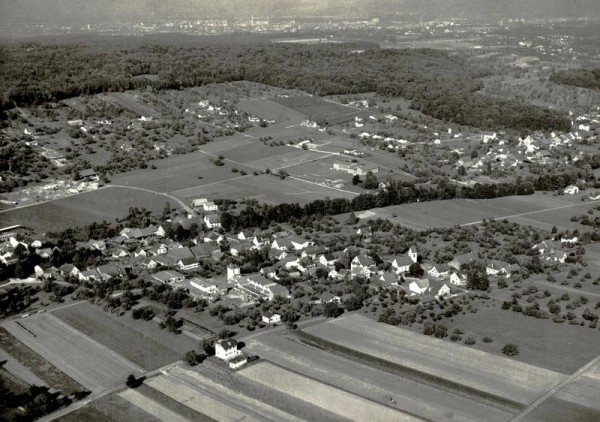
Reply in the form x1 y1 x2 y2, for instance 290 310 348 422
0 0 600 24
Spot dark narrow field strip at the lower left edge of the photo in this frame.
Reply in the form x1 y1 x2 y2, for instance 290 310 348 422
0 326 84 394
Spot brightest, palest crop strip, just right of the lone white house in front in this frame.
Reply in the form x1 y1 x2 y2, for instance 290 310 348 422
240 362 418 421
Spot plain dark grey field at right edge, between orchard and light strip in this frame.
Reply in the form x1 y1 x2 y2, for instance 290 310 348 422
450 305 600 374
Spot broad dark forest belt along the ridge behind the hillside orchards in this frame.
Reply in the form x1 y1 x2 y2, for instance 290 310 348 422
0 43 570 131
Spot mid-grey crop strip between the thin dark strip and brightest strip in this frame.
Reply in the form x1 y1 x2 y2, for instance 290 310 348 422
244 334 511 421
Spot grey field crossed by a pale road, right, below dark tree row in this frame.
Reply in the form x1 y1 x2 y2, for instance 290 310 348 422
357 193 598 231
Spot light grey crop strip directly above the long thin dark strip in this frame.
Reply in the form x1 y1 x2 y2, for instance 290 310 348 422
304 314 565 404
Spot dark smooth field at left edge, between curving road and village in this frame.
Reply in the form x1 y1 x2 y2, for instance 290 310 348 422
0 187 177 232
